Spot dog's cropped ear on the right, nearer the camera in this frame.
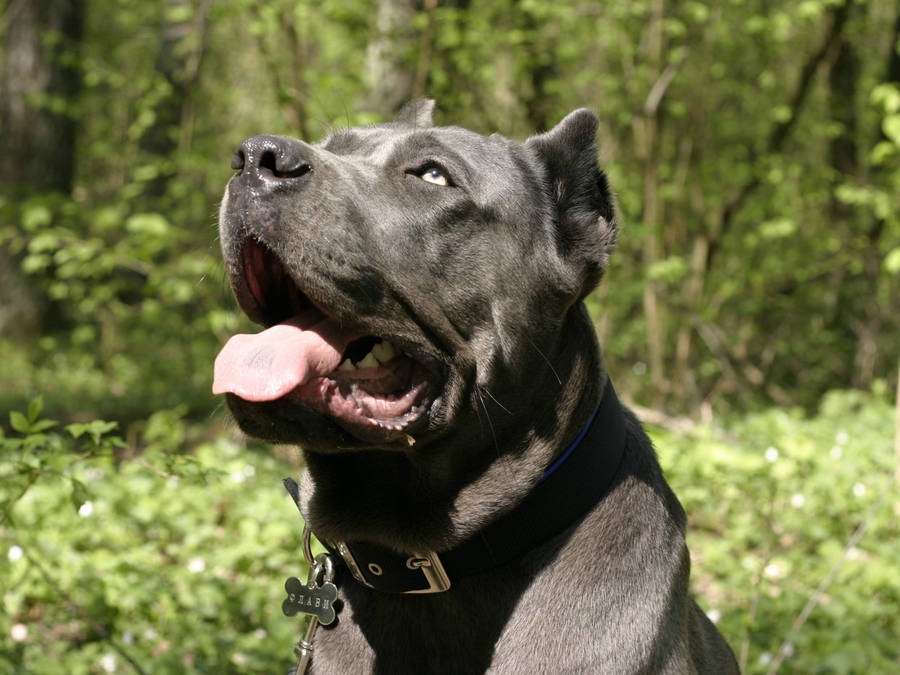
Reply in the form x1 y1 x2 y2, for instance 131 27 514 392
525 108 618 299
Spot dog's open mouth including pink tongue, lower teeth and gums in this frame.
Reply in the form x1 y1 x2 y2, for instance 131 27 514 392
213 239 431 440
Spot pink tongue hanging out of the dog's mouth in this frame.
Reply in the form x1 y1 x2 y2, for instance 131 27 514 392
213 310 358 401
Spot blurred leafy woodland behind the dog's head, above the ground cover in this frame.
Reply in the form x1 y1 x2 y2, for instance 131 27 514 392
0 0 900 418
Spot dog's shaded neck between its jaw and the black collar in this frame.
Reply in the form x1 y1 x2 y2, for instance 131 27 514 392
301 304 606 552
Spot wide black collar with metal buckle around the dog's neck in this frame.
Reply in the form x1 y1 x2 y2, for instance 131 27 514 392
284 380 625 593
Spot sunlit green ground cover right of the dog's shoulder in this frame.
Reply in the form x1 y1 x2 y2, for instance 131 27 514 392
652 391 900 674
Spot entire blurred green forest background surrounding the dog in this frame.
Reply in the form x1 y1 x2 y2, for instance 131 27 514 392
0 0 900 673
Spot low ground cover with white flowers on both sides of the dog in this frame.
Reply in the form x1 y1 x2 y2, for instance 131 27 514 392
0 391 900 674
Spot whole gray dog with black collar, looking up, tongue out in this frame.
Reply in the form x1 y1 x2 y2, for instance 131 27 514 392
214 101 737 675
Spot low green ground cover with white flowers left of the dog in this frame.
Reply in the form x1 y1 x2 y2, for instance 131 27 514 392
0 399 306 673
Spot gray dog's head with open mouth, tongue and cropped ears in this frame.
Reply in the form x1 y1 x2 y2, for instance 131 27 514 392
214 101 616 460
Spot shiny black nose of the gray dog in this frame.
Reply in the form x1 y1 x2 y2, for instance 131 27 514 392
231 136 312 183
